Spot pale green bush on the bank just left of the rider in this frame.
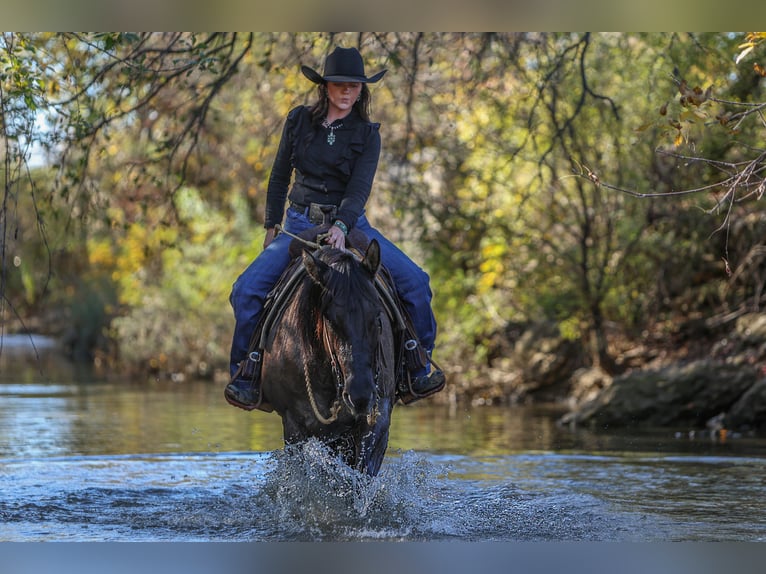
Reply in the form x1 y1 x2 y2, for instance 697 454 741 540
111 188 263 375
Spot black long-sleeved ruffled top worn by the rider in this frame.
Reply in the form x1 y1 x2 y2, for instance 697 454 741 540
265 106 380 229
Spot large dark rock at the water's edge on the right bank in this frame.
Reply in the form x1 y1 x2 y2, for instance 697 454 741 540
560 359 757 428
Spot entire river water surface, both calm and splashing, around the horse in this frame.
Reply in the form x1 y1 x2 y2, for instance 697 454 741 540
0 371 766 542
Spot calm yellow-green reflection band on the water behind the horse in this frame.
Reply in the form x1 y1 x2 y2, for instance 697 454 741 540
0 380 766 458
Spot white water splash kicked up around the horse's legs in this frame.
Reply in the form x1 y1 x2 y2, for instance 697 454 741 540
254 440 443 541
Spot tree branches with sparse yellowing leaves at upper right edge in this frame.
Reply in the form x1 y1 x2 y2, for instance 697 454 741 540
592 32 766 318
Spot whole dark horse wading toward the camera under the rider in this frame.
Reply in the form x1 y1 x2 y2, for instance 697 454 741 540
261 240 396 476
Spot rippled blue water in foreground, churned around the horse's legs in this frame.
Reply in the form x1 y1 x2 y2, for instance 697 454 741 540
0 441 764 541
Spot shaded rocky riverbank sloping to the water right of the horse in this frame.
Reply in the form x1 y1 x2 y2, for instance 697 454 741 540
439 313 766 431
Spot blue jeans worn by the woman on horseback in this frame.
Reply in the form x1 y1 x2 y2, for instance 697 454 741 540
229 208 436 375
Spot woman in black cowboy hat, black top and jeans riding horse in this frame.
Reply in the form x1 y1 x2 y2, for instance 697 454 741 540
225 47 444 410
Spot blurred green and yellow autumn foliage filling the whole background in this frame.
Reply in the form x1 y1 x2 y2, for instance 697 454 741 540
0 33 764 384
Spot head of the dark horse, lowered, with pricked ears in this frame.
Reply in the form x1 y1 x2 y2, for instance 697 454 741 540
303 240 383 424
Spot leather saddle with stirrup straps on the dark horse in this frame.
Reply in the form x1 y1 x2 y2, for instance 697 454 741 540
240 224 432 412
